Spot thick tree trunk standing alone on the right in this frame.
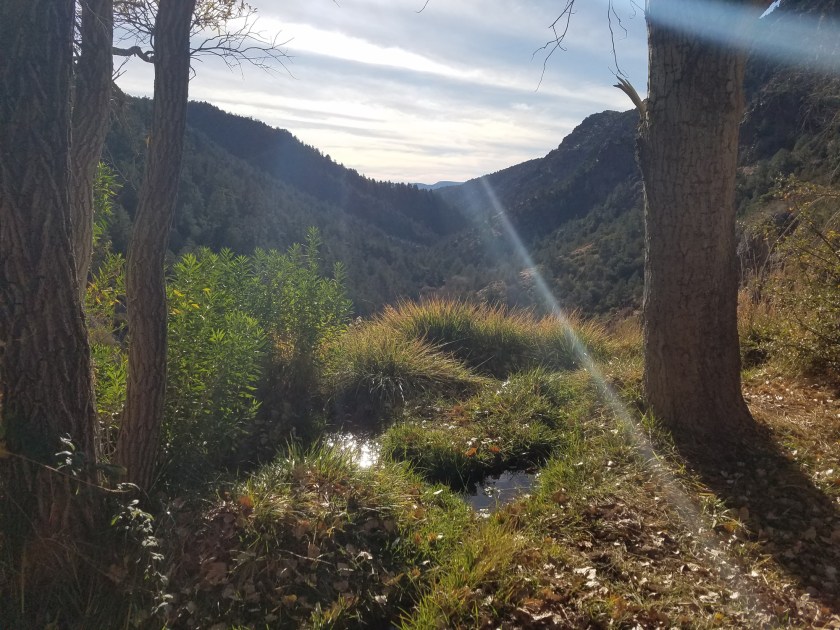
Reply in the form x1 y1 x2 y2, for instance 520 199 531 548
639 0 757 445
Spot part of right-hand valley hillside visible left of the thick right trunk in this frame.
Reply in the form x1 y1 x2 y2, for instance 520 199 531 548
437 111 644 312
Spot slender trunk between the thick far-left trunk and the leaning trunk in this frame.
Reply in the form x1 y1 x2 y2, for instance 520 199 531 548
70 0 114 301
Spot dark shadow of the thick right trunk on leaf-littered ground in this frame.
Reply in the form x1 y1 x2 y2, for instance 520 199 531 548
675 424 840 614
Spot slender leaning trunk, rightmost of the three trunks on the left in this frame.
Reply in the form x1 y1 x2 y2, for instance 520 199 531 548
117 0 195 490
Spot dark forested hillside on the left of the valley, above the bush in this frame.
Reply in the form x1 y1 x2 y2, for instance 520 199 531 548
105 97 458 314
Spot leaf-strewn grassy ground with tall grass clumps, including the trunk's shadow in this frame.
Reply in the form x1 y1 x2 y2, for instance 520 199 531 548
8 304 840 630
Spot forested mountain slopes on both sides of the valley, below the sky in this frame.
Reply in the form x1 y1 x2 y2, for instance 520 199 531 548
106 0 840 314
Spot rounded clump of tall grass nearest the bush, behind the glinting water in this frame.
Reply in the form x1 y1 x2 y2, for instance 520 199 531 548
324 322 481 422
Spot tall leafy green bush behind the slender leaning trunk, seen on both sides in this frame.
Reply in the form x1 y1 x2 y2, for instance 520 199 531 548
87 230 350 481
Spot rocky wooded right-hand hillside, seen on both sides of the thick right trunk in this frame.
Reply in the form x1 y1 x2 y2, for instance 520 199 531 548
430 1 840 313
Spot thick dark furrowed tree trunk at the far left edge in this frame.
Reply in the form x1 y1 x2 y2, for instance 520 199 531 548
0 0 94 544
